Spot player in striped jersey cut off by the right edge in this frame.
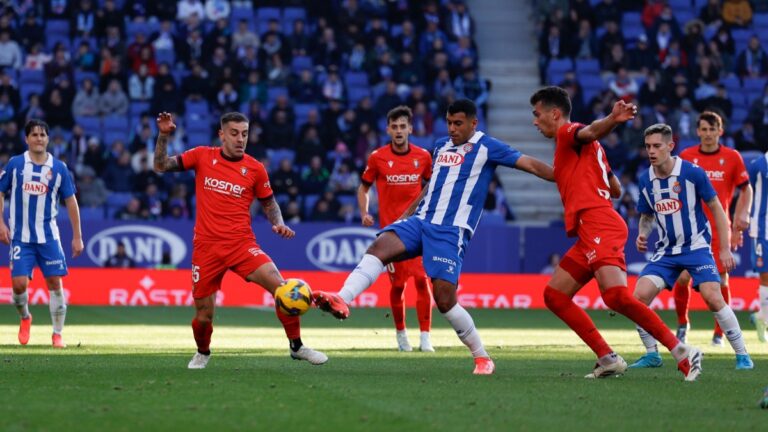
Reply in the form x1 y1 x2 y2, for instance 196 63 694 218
748 153 768 342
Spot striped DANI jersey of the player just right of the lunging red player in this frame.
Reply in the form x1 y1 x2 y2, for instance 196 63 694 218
637 157 717 255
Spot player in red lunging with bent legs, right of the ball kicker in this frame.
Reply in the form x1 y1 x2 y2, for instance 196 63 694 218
530 87 702 380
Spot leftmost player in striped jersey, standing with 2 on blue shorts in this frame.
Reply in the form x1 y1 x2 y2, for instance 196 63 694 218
0 120 83 348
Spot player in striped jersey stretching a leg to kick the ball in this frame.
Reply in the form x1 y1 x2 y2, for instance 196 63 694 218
315 99 553 375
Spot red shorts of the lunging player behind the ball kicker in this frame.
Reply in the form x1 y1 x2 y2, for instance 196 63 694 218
560 208 629 284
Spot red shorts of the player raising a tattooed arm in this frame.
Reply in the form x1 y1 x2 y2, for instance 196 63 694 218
192 240 272 299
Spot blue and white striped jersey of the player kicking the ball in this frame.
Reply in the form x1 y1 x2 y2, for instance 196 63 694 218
415 131 522 233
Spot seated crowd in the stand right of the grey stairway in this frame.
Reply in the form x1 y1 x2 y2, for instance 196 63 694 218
534 0 768 225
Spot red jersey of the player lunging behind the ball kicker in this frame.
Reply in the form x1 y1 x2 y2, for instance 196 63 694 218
553 123 613 236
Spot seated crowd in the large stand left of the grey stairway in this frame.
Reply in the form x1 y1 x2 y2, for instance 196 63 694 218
0 0 504 222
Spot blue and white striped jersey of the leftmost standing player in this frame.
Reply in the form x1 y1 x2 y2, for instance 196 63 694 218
0 152 75 243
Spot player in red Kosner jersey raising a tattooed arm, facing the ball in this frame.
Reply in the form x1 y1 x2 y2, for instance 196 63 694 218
154 112 328 369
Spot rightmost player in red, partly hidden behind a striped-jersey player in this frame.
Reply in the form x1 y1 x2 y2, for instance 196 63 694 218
672 111 752 346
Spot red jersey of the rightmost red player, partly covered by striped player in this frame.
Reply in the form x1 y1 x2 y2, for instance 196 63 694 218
680 144 749 226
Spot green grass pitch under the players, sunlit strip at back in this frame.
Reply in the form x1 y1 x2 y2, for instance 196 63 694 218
0 307 768 432
